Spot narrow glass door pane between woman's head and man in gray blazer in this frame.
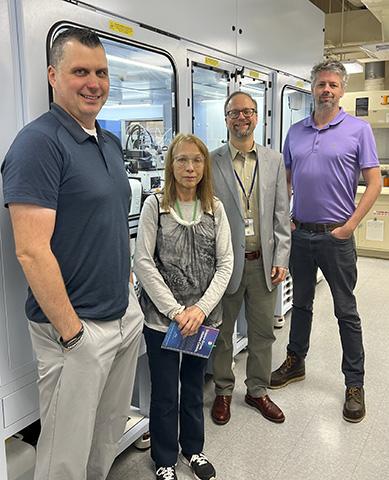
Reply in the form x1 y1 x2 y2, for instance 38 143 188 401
192 62 230 150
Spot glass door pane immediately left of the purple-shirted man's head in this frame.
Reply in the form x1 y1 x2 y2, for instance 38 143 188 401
281 86 313 150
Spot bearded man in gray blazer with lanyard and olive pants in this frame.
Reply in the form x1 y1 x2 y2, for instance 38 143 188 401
211 92 290 425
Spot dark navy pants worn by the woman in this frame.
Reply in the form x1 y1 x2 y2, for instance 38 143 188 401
144 327 207 467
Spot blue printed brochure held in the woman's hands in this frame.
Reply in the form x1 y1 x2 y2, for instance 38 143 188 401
162 321 219 358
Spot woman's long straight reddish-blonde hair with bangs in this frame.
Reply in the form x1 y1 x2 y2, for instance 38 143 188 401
161 133 214 212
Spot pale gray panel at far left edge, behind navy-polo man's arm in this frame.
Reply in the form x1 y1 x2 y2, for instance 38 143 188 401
0 0 35 393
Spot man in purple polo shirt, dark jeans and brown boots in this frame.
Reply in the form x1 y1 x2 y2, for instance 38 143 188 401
271 60 381 422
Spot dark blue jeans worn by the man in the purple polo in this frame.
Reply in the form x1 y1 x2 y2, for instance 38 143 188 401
288 229 365 387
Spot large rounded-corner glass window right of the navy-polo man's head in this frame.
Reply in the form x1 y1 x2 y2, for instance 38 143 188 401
98 39 176 170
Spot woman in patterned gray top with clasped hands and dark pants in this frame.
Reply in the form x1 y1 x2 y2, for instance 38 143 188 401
134 134 233 480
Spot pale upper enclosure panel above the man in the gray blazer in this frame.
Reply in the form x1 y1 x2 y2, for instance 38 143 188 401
237 0 324 78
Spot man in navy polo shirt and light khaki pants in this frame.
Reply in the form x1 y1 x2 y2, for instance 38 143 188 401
2 28 142 480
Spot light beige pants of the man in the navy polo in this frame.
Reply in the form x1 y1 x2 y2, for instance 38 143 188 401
29 288 143 480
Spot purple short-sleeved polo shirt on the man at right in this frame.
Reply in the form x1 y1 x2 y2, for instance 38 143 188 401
283 108 379 223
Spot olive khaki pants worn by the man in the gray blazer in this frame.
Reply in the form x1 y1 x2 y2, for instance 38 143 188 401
213 259 277 397
